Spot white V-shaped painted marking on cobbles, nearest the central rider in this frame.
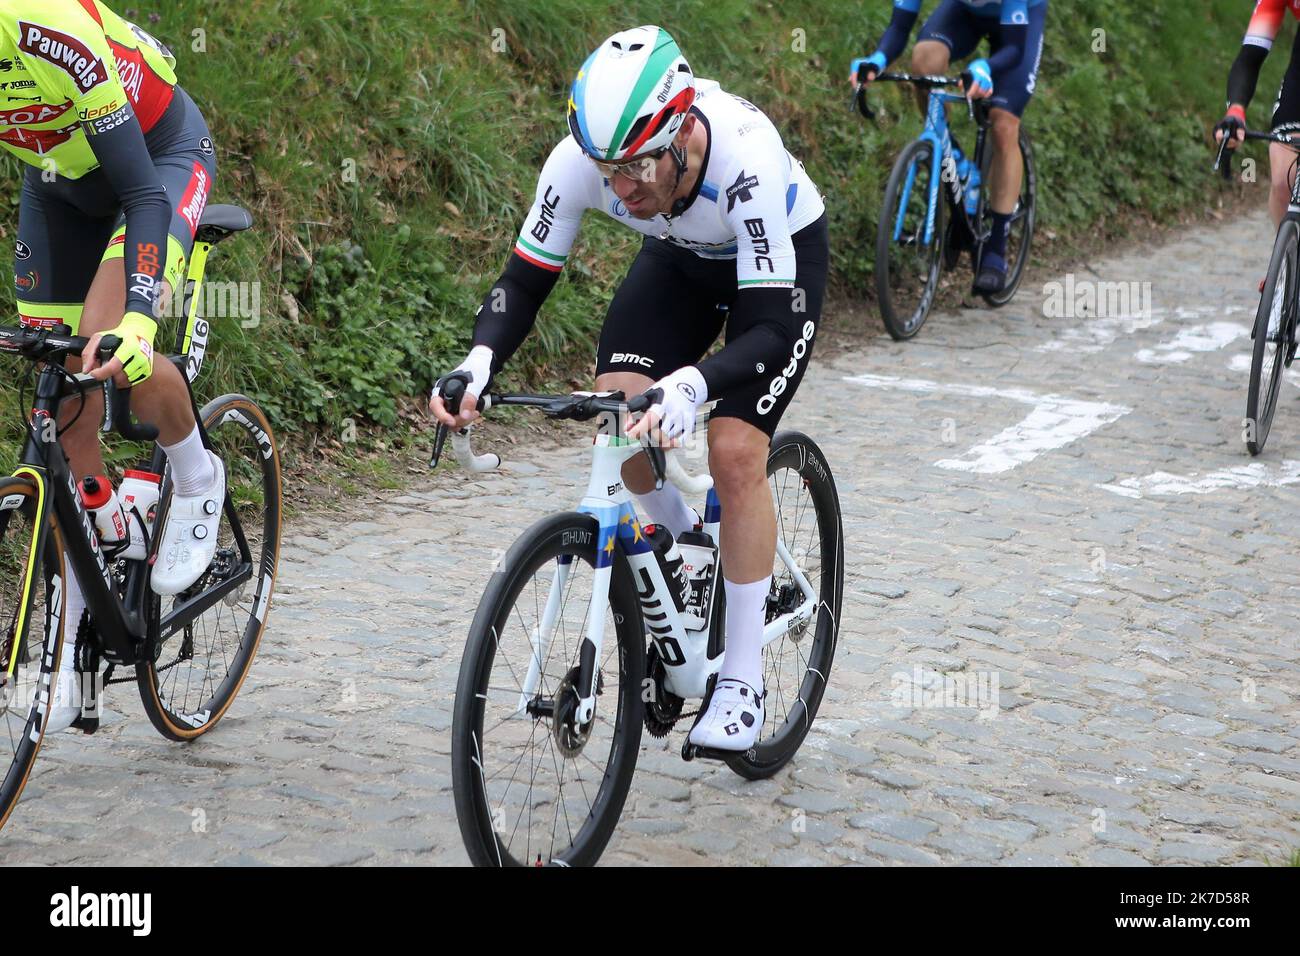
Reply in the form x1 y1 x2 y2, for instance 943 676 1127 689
845 375 1132 475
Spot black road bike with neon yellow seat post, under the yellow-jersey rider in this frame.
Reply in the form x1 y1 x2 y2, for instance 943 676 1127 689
0 206 281 826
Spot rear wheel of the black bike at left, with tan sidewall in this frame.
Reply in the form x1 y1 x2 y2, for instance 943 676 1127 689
135 395 282 740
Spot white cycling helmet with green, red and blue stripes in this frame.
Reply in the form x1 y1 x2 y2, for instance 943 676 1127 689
568 26 696 163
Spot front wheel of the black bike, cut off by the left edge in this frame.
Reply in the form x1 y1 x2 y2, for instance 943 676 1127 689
0 479 64 827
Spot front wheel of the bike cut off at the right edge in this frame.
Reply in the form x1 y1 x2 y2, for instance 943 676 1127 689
1245 219 1300 455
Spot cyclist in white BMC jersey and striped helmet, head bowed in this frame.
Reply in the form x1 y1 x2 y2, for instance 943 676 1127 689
430 26 829 750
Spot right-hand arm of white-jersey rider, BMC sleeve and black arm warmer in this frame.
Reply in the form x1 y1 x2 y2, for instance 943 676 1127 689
698 150 809 397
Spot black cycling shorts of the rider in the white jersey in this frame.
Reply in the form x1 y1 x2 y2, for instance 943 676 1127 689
595 215 831 438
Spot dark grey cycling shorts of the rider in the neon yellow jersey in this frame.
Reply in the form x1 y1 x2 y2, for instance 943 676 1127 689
13 87 217 333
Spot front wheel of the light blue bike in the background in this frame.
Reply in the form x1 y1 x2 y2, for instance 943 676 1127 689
875 139 946 341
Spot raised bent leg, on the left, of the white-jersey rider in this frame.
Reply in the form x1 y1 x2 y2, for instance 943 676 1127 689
595 238 736 533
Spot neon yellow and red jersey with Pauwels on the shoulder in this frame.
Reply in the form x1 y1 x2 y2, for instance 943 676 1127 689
0 0 176 179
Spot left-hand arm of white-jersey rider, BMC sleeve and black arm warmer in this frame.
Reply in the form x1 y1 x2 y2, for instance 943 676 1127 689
473 138 599 375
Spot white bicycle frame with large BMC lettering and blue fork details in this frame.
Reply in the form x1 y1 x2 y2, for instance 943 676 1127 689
519 432 816 723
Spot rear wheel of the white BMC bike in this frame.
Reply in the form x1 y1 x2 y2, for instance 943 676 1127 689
727 432 844 780
